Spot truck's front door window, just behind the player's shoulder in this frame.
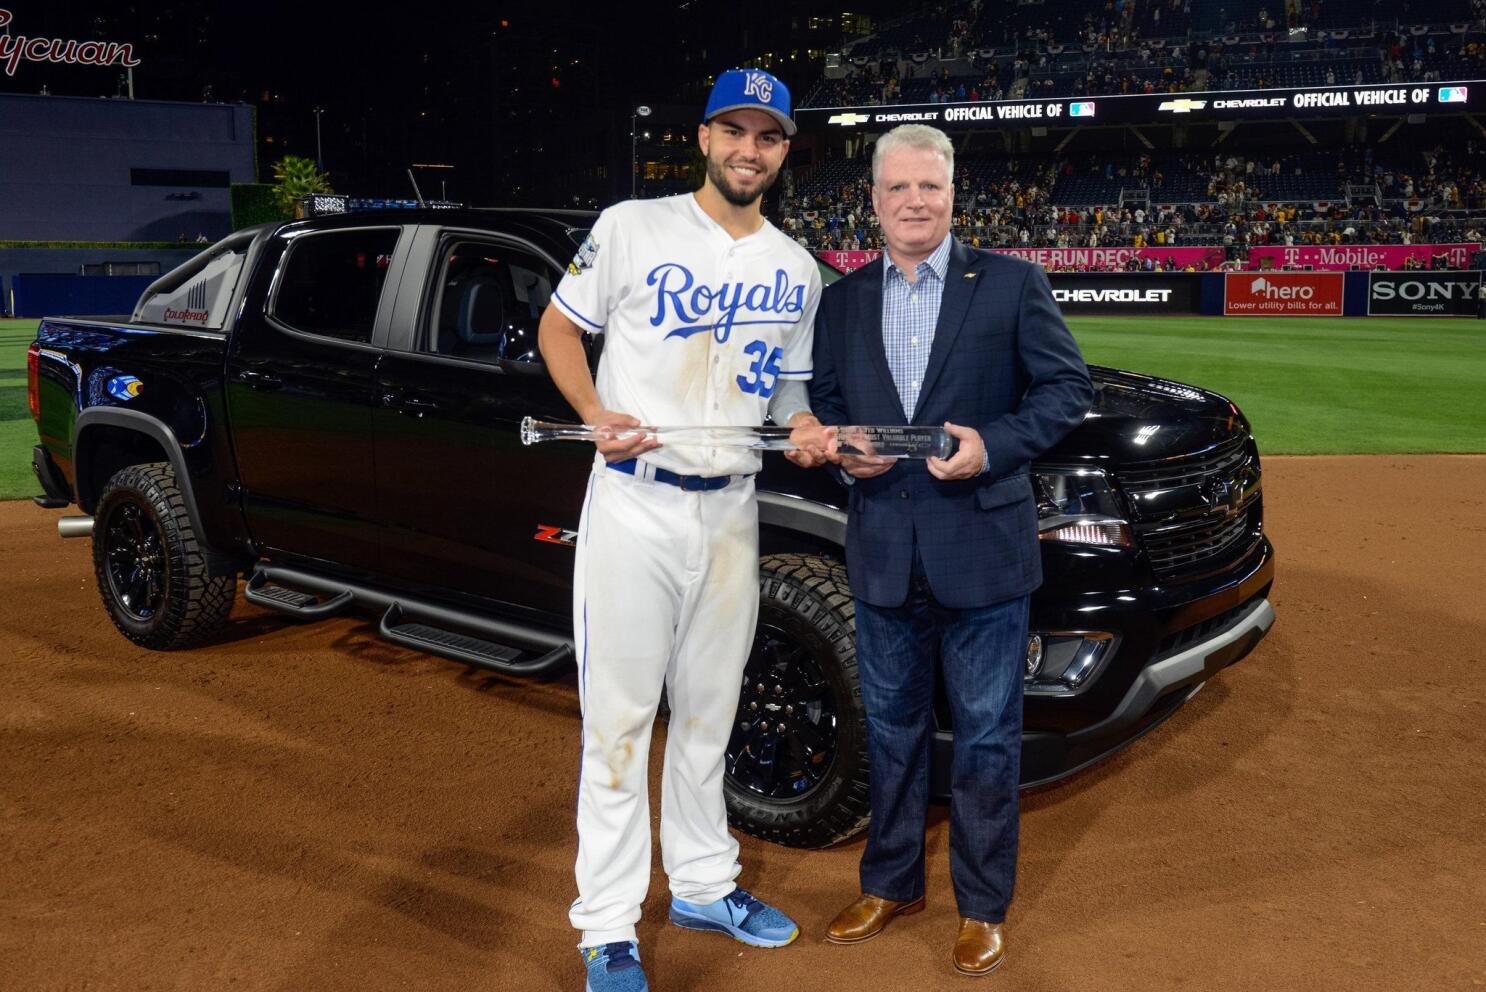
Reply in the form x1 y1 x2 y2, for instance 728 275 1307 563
428 241 553 365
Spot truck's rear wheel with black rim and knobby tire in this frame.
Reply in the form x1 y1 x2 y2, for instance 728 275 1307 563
92 462 238 650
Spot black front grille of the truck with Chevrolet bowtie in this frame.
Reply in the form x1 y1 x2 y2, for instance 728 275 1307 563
1117 437 1263 579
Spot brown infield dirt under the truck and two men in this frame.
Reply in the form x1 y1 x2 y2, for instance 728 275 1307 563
0 456 1486 992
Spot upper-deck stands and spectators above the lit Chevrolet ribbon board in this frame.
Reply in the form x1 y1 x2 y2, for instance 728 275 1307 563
801 0 1486 107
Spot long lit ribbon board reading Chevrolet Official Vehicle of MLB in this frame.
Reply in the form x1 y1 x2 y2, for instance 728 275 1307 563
795 80 1486 134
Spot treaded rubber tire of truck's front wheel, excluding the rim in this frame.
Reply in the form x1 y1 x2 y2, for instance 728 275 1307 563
724 554 869 848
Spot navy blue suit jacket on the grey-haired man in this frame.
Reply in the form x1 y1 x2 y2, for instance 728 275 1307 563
810 241 1094 609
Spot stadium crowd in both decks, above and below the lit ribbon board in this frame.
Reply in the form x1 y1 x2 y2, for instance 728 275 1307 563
776 0 1486 266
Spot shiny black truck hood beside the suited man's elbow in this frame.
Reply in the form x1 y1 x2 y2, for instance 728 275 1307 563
1037 365 1250 466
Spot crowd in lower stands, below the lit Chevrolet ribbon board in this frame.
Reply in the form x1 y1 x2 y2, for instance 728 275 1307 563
777 141 1486 257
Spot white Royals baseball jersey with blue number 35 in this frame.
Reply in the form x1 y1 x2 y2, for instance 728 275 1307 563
553 193 820 475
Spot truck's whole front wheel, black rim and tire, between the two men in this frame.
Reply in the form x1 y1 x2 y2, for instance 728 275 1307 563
724 554 869 848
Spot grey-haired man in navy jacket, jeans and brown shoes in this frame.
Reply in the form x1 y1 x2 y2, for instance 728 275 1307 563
810 125 1092 974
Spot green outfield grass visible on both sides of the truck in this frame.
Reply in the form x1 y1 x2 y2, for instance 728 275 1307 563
0 316 1486 499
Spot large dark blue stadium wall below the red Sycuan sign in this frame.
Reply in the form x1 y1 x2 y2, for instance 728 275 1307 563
0 94 257 241
